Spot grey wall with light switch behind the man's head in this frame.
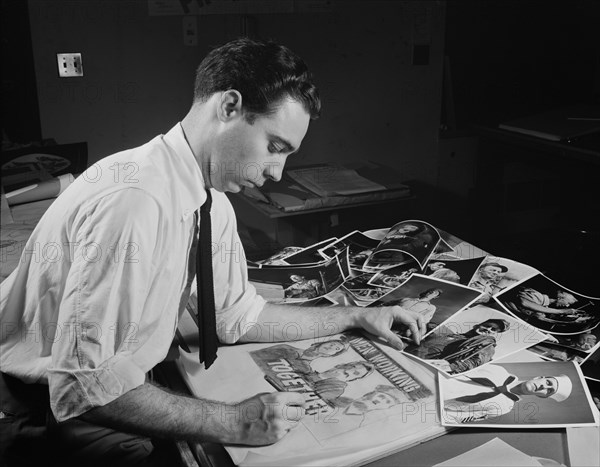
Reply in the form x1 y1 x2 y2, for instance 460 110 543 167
29 0 445 187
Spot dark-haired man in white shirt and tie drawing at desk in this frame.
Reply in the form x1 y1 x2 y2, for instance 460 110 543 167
0 39 423 465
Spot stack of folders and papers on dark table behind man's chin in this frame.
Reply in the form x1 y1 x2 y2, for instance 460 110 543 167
244 163 410 212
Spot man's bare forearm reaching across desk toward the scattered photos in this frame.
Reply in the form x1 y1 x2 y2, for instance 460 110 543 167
240 303 366 342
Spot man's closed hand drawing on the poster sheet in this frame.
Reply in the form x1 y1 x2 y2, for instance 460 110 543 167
227 392 305 446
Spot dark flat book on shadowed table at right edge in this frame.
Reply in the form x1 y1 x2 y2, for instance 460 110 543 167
498 106 600 141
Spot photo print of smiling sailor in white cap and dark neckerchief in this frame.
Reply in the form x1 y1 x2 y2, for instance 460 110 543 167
439 362 598 428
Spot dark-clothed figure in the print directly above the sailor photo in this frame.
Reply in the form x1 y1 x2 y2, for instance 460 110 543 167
407 319 509 374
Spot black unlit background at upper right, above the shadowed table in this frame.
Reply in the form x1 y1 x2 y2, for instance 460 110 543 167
446 0 600 127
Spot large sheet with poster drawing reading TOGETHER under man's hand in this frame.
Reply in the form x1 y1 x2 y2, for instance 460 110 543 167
179 333 446 465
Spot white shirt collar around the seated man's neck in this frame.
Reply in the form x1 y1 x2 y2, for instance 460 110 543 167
163 122 207 220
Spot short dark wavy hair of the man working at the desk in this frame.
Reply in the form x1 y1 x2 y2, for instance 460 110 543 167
194 38 321 124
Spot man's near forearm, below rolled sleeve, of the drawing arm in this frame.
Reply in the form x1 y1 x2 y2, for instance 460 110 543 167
80 383 242 442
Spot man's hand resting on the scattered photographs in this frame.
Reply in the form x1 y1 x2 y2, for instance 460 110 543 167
357 306 427 350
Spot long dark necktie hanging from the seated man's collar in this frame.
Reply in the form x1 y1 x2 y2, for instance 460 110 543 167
196 190 218 368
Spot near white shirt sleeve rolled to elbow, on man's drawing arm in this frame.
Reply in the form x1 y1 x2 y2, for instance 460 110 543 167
48 188 161 421
